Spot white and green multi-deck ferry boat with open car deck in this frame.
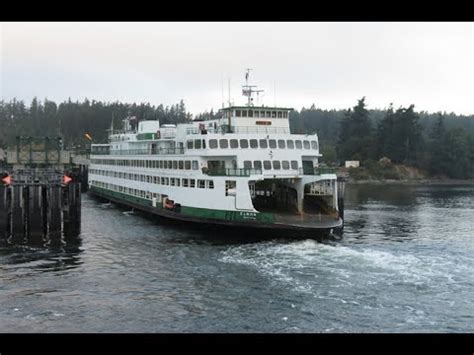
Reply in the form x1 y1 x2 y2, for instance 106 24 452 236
88 71 343 234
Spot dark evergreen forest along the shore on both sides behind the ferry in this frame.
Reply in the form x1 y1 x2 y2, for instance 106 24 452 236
0 98 474 179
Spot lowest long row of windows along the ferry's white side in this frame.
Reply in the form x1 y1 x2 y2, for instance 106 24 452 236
89 169 214 189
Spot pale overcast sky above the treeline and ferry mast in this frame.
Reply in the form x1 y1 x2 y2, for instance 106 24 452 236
0 22 474 114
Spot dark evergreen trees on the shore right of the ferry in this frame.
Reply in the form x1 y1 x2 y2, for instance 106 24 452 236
290 97 474 179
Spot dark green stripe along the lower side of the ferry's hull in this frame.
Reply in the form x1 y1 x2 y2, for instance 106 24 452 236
90 186 275 223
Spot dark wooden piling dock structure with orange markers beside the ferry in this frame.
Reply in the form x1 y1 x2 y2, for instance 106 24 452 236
0 137 87 246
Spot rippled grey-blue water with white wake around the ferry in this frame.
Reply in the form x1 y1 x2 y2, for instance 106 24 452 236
0 185 474 333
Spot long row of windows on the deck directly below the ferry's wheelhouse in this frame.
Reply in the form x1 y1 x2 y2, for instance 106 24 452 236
187 139 318 150
